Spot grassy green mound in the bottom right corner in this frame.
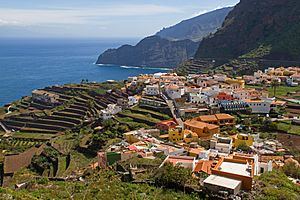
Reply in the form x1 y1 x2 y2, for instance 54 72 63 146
255 170 300 200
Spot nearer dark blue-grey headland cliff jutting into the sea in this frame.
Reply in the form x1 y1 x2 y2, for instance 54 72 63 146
97 36 199 67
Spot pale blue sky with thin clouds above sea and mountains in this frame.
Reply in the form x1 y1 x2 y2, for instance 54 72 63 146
0 0 239 38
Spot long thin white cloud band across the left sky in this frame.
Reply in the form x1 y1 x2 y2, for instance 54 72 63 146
0 4 182 26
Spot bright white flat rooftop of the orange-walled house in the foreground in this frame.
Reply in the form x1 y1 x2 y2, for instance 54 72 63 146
219 161 251 177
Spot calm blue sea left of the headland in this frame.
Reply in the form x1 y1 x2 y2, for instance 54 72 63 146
0 39 169 106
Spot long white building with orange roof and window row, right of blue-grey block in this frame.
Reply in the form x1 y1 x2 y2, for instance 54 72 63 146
245 98 273 114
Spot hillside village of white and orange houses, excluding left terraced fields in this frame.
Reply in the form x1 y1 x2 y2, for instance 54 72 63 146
98 67 300 195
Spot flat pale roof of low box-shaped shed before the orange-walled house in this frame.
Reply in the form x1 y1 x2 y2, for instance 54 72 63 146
204 175 242 189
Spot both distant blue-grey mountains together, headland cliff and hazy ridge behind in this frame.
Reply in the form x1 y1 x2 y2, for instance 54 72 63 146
96 8 231 68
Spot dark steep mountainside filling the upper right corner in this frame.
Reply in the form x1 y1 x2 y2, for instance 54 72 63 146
195 0 300 60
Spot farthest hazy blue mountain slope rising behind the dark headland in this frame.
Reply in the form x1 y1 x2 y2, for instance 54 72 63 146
156 7 233 42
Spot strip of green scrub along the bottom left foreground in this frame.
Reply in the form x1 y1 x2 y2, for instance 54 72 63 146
0 171 200 200
